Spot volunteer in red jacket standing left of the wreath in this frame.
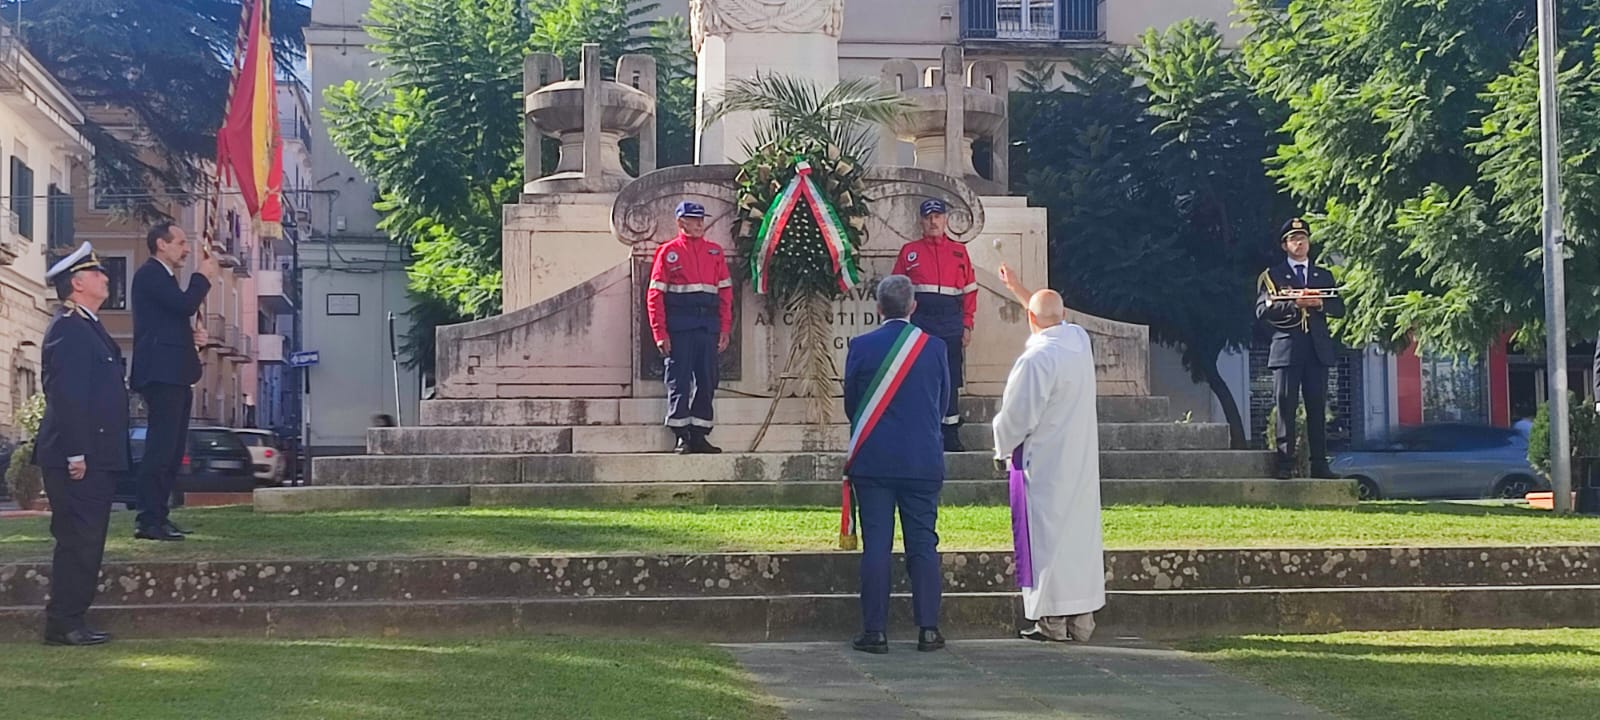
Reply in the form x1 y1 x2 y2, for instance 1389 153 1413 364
645 202 733 454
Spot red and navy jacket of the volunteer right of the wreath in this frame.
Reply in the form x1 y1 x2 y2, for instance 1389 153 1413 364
894 235 978 338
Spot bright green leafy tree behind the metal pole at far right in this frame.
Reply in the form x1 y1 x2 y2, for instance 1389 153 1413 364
1240 0 1600 355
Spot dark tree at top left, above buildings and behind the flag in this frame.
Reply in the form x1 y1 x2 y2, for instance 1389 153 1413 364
0 0 310 221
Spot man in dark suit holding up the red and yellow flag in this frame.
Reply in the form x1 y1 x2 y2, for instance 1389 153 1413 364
130 222 218 541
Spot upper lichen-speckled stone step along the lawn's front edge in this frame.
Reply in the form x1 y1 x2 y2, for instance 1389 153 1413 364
0 546 1574 606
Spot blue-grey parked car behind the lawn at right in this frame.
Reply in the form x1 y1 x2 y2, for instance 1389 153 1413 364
1331 424 1549 499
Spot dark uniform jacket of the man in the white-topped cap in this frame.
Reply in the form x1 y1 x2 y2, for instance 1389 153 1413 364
34 307 128 470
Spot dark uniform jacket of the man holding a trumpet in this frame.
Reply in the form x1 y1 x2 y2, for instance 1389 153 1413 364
1256 259 1344 368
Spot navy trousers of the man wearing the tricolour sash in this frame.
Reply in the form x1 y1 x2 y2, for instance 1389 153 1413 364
851 478 944 632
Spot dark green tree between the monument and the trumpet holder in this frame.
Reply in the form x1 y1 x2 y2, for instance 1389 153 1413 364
1011 21 1283 446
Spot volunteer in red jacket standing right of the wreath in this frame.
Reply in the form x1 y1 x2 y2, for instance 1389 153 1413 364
894 198 978 453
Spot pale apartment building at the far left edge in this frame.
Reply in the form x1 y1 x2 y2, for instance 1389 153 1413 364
0 24 94 440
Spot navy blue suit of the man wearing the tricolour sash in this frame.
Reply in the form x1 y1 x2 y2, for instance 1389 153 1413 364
845 320 952 632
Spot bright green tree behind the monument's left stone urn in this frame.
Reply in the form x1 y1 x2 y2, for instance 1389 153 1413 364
323 0 694 371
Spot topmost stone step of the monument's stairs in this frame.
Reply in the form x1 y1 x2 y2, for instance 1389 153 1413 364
421 395 1173 427
